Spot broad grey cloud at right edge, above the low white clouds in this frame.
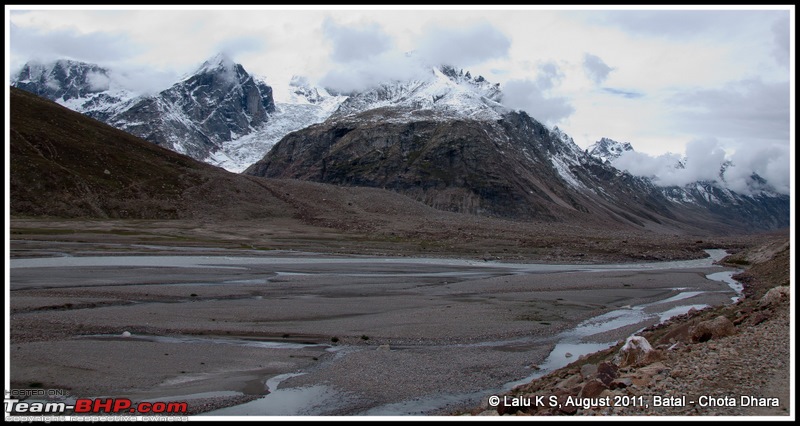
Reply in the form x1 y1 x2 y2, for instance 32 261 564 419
670 79 790 144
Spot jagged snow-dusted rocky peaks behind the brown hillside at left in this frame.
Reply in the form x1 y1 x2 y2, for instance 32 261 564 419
11 54 275 160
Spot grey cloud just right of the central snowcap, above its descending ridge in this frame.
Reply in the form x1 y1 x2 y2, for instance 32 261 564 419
503 66 575 124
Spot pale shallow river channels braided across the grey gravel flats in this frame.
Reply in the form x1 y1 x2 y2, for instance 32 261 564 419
11 250 740 416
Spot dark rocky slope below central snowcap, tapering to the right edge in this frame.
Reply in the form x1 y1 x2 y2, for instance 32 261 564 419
245 104 789 232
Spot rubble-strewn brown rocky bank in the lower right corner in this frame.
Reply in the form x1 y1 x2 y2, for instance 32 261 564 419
470 233 791 416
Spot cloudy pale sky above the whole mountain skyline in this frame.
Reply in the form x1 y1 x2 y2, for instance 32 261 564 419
6 6 794 193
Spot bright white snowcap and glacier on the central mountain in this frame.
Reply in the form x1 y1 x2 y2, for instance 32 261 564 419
204 66 506 173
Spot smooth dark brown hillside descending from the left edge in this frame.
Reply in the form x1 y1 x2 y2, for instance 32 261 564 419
10 88 292 219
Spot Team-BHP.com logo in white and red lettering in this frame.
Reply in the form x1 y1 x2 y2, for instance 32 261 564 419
3 393 189 416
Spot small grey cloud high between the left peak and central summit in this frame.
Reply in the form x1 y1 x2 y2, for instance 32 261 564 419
322 18 394 63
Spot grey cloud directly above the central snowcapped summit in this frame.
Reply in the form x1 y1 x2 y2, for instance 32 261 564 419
415 22 511 67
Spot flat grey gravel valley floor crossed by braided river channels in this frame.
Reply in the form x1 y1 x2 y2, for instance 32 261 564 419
10 220 788 415
